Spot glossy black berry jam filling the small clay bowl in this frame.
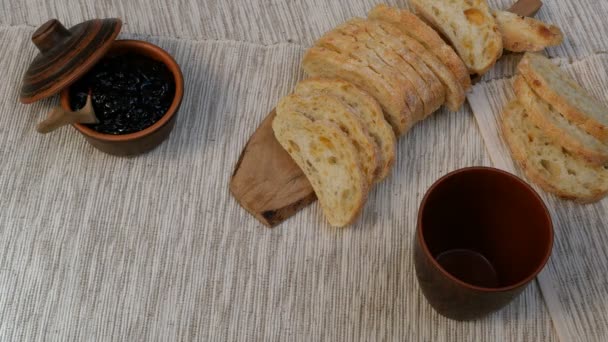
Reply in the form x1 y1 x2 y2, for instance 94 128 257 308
70 54 175 134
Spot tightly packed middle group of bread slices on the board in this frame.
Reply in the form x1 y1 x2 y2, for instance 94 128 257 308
303 5 471 135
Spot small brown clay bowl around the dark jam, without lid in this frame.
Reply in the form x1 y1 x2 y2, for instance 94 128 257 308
61 40 184 156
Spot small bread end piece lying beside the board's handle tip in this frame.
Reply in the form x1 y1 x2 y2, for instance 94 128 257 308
492 10 564 52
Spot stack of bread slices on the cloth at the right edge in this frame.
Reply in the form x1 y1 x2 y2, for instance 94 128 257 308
502 53 608 203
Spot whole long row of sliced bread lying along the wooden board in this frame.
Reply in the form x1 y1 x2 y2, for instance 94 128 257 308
273 0 564 226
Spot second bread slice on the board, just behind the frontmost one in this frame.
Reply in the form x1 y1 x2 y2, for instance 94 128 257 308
277 94 379 184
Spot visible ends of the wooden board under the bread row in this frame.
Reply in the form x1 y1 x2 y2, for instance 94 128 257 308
230 0 542 227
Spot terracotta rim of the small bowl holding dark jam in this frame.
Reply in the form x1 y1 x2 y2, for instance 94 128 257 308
61 39 184 142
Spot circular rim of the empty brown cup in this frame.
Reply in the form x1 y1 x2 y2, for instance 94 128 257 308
416 166 554 293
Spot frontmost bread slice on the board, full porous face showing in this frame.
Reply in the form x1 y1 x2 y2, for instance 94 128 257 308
272 112 368 227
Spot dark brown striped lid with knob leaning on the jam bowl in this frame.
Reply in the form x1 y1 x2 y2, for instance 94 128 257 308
19 18 122 103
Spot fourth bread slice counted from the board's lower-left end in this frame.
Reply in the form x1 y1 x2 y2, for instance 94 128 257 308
315 25 424 127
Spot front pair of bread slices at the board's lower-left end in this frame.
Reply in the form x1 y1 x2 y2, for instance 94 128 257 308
272 78 395 227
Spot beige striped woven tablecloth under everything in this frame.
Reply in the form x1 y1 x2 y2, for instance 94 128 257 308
0 0 608 341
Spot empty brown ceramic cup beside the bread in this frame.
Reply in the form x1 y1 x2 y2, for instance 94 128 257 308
414 167 553 320
